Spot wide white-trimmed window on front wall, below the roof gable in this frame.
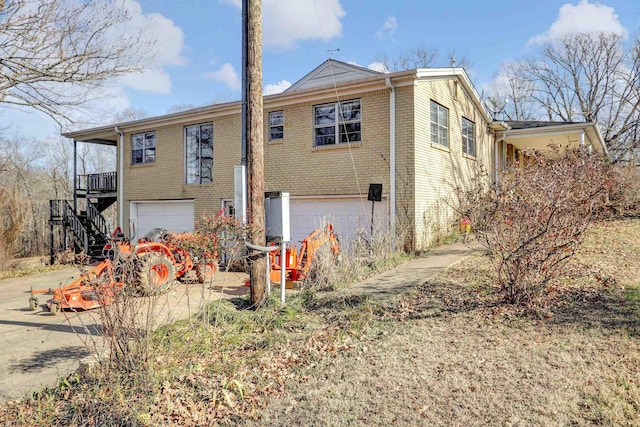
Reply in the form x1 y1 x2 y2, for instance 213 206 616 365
313 99 362 147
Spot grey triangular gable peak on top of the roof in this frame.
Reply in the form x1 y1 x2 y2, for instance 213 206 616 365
284 59 383 93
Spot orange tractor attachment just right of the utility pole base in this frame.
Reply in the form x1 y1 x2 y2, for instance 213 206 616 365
269 224 340 289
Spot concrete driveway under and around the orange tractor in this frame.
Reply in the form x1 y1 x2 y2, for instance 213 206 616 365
0 268 248 401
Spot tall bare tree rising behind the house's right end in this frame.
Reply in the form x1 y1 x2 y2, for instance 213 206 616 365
524 33 640 161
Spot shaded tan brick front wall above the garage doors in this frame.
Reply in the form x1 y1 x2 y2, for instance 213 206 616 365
119 90 389 234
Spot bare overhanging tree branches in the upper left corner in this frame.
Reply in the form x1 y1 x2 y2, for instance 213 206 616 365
0 0 149 123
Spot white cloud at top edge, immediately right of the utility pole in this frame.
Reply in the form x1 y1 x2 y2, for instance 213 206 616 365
219 0 346 50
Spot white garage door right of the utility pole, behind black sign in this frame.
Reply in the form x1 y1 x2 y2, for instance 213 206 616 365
289 197 389 247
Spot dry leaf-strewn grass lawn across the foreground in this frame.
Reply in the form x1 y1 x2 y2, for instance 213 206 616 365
0 220 640 426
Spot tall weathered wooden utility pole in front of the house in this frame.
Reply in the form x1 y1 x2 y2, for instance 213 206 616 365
244 0 267 308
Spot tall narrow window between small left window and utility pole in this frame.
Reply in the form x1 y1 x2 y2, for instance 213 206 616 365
184 123 213 184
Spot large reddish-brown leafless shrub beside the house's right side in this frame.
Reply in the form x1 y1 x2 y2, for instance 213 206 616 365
463 151 612 307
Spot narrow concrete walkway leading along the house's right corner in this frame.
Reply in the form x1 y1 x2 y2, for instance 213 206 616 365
343 241 482 298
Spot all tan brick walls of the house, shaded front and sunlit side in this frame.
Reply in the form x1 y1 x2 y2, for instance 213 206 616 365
117 80 493 250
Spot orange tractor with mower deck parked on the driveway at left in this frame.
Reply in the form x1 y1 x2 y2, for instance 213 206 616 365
29 229 218 314
